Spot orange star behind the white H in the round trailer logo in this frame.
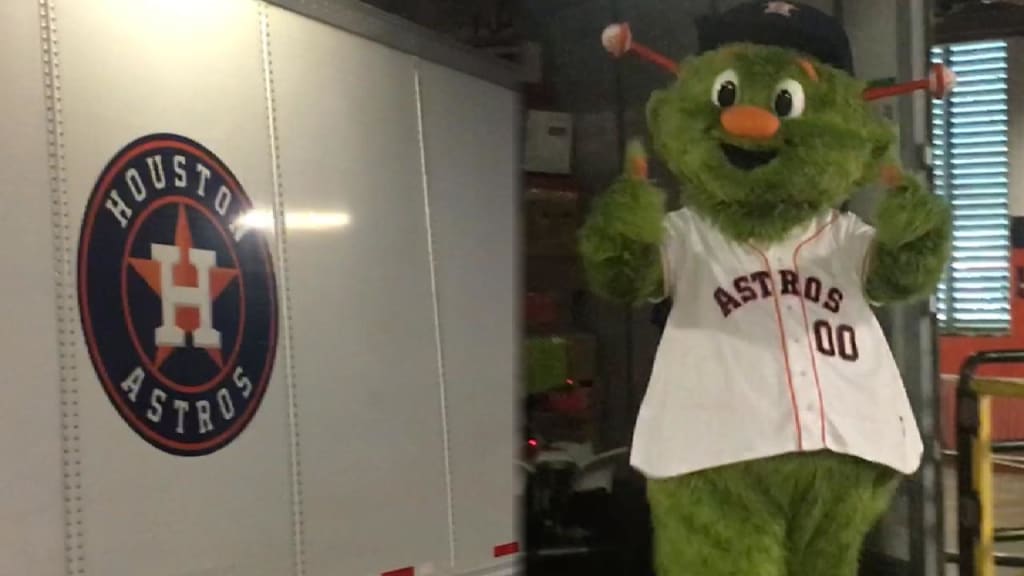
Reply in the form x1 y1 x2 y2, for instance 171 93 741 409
128 205 239 368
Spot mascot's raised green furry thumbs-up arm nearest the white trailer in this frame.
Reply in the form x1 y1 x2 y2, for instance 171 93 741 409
580 142 665 303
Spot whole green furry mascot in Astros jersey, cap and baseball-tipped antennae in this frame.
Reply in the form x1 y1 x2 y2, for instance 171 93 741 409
581 1 952 576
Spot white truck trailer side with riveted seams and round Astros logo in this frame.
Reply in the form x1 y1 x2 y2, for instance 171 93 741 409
0 0 520 576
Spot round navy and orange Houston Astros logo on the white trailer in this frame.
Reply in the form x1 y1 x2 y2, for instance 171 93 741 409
78 134 278 456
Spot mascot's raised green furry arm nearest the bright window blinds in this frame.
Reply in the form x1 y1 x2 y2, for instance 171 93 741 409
865 169 952 303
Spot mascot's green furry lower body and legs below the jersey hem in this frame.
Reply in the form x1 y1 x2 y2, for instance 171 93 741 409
648 453 898 576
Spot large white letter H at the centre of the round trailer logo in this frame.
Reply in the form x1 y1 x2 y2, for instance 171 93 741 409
151 244 220 348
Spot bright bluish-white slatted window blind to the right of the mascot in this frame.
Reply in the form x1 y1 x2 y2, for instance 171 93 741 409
931 41 1010 333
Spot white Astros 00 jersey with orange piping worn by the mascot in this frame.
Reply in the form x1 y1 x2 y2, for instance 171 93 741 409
631 209 923 478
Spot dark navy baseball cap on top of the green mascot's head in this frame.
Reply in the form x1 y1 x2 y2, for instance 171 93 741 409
697 0 853 75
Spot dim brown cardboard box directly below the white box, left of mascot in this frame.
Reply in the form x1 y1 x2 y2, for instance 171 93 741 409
526 189 580 256
